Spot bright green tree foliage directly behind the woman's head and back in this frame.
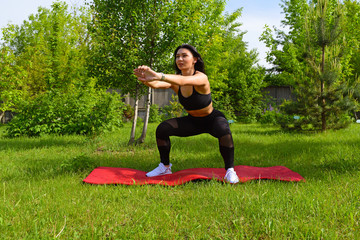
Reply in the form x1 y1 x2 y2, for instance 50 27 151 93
179 5 265 122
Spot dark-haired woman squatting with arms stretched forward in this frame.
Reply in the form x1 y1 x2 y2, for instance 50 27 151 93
134 44 239 183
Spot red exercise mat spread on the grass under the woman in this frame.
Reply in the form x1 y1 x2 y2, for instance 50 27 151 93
83 166 305 186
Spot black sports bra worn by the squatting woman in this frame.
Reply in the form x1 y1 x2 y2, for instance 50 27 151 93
178 86 211 110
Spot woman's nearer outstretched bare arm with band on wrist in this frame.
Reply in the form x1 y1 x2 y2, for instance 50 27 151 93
134 66 209 87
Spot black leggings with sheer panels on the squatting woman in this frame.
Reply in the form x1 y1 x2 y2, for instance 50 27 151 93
156 110 234 169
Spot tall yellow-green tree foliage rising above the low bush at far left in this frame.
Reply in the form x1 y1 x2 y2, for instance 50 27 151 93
3 2 90 97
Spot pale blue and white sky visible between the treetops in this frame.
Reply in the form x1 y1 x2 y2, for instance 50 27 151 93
0 0 283 67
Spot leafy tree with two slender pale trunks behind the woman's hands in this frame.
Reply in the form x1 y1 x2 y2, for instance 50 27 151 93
91 0 256 143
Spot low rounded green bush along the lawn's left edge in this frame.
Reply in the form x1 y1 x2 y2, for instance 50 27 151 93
7 91 124 137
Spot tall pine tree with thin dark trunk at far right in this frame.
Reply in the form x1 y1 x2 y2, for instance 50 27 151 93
305 0 348 131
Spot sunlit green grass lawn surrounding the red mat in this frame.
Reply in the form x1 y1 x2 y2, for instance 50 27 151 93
0 124 360 239
